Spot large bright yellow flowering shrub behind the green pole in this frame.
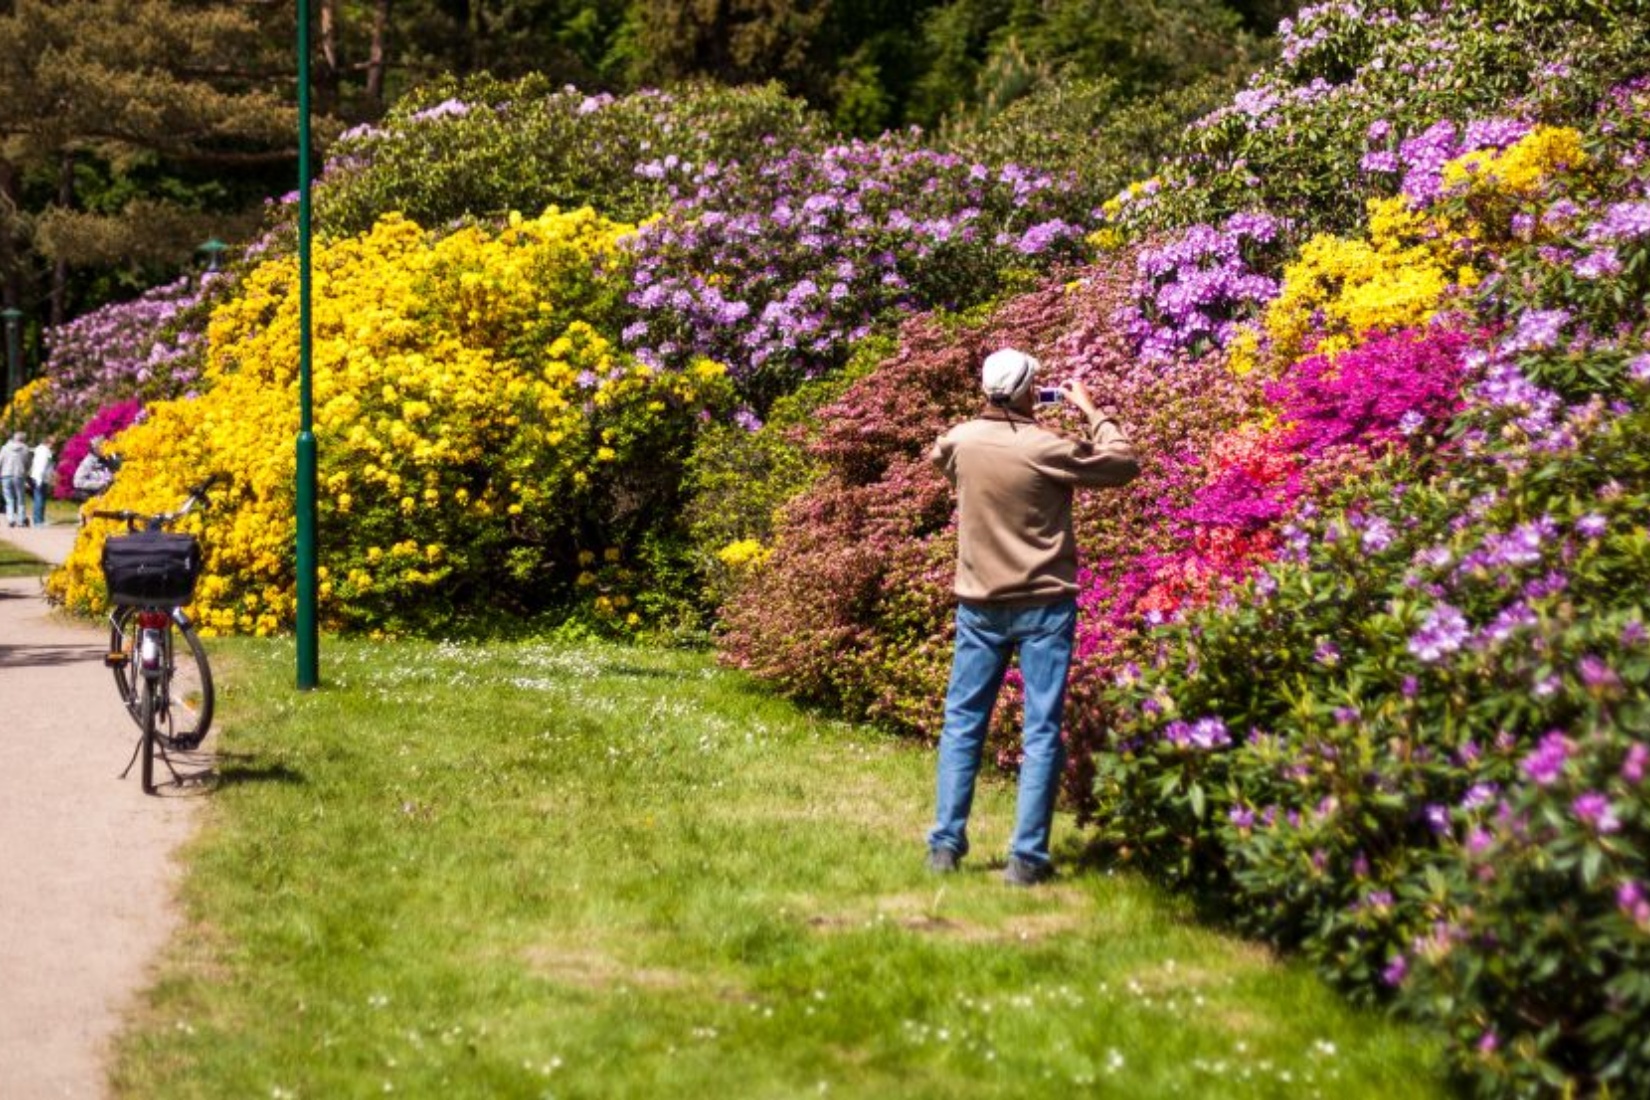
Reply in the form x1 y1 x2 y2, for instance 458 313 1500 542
50 209 726 633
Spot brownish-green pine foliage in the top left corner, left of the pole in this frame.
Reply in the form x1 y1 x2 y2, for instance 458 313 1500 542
0 0 295 352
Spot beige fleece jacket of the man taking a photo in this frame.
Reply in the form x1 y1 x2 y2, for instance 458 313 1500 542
929 409 1140 604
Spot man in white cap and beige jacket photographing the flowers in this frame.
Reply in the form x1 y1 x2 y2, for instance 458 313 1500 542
927 348 1140 886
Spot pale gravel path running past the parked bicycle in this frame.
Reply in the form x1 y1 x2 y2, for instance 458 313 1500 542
0 526 200 1100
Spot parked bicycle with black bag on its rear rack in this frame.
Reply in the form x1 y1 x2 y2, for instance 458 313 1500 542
89 475 219 795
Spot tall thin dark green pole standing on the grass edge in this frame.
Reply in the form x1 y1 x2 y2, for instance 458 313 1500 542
295 0 320 691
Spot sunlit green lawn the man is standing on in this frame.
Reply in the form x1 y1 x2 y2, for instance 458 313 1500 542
114 642 1447 1100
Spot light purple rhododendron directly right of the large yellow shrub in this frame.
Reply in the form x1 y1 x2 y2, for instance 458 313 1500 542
624 135 1087 406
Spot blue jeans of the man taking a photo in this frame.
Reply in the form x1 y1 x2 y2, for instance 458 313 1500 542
929 600 1077 867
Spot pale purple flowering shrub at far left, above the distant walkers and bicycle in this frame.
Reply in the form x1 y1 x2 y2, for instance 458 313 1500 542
31 274 226 451
